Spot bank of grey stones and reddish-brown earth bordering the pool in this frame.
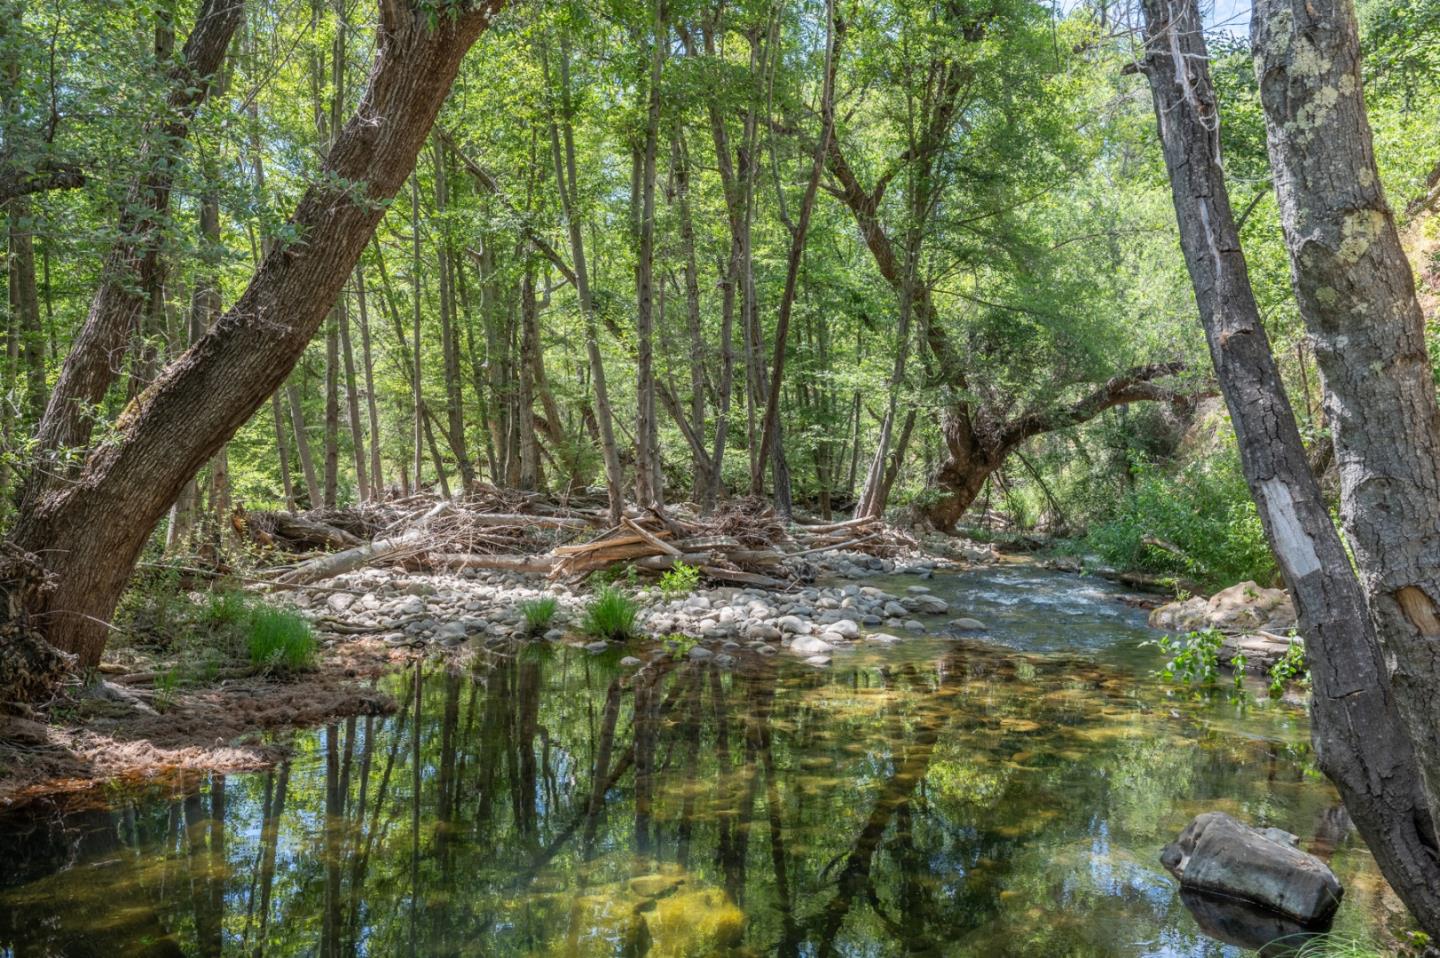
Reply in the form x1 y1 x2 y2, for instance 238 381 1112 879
0 530 989 807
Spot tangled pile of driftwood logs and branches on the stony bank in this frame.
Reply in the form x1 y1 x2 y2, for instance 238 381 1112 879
249 488 916 588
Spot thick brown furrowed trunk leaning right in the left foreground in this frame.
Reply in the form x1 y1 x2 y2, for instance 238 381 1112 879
5 0 504 666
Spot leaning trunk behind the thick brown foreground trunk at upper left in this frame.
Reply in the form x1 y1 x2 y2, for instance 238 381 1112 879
27 0 245 475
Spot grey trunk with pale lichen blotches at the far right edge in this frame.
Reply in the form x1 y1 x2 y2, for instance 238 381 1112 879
1251 0 1440 847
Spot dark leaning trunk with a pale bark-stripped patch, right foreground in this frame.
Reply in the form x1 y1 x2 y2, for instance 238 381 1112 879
1143 0 1440 934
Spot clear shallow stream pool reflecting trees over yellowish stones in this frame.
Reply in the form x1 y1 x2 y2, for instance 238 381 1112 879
0 568 1390 957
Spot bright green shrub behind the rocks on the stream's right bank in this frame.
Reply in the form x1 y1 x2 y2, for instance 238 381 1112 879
1087 452 1277 589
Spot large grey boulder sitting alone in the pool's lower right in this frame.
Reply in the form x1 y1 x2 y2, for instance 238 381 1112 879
1161 811 1345 925
